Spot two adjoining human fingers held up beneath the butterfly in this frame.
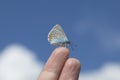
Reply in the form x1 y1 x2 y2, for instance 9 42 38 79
38 47 81 80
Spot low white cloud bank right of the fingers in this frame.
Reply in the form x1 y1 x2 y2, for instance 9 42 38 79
79 63 120 80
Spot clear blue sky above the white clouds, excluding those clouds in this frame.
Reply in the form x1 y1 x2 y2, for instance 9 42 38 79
0 0 120 71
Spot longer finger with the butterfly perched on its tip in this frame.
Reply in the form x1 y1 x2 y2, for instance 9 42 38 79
39 47 69 80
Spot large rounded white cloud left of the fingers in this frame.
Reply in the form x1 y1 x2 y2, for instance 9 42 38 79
0 45 43 80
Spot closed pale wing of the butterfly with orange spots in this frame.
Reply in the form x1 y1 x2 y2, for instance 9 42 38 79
48 24 68 44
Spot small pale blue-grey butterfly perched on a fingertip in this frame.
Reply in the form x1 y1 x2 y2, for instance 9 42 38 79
48 24 70 47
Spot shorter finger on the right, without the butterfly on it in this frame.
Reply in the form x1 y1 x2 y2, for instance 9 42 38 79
59 58 81 80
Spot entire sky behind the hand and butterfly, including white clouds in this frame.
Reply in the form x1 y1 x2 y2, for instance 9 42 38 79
0 0 120 80
